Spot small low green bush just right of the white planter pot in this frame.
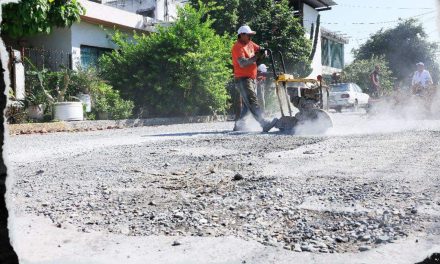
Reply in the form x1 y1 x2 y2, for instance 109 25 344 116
91 81 134 119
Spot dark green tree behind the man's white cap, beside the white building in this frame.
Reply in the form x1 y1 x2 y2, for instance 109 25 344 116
190 0 312 76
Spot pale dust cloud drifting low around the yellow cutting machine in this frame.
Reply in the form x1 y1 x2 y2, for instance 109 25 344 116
237 91 440 136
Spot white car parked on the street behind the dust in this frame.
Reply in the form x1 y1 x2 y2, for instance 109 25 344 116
329 83 370 112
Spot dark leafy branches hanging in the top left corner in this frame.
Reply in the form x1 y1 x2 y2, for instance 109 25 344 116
1 0 85 39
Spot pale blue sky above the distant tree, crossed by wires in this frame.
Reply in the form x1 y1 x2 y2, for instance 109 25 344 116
321 0 440 64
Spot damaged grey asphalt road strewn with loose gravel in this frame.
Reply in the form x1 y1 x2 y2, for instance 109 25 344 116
8 115 440 262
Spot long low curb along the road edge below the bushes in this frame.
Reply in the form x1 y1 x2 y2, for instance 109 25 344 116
7 116 232 135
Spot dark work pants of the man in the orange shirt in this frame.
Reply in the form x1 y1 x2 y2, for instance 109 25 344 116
235 78 266 127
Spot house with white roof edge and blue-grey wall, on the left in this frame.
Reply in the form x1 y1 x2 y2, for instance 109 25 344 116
13 0 179 69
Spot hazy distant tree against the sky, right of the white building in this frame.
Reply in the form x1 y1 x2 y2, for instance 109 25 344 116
354 19 440 85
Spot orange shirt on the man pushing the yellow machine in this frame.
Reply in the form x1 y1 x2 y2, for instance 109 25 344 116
232 41 260 79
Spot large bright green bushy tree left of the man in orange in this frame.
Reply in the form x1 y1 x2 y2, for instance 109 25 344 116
100 5 232 116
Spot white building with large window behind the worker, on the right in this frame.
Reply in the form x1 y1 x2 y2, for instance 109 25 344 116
290 0 348 77
